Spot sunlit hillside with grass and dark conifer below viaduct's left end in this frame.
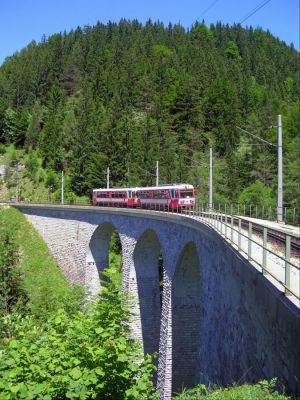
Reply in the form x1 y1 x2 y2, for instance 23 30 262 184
0 208 83 322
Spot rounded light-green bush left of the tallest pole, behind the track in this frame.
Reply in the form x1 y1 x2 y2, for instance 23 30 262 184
239 181 276 206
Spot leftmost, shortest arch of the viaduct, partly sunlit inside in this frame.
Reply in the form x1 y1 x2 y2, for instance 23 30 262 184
86 222 118 294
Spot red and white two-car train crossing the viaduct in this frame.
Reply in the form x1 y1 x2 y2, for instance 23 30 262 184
92 183 195 210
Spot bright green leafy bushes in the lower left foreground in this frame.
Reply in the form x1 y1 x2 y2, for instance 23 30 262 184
0 268 156 400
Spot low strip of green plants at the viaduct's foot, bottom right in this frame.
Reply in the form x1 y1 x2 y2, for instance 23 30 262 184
174 379 290 400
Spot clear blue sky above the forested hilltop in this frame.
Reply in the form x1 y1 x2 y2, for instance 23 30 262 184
0 0 299 64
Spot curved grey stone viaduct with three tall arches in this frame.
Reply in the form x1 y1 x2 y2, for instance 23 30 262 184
13 205 300 399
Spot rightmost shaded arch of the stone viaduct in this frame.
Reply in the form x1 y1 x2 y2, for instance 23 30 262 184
172 242 201 392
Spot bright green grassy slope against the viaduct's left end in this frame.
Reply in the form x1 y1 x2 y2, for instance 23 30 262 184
0 208 83 318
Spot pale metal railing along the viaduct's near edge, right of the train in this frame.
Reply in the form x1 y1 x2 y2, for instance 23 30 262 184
179 208 300 306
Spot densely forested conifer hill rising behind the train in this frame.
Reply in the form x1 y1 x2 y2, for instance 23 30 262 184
0 20 300 207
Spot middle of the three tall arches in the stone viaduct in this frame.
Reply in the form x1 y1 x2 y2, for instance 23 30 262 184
133 229 162 354
